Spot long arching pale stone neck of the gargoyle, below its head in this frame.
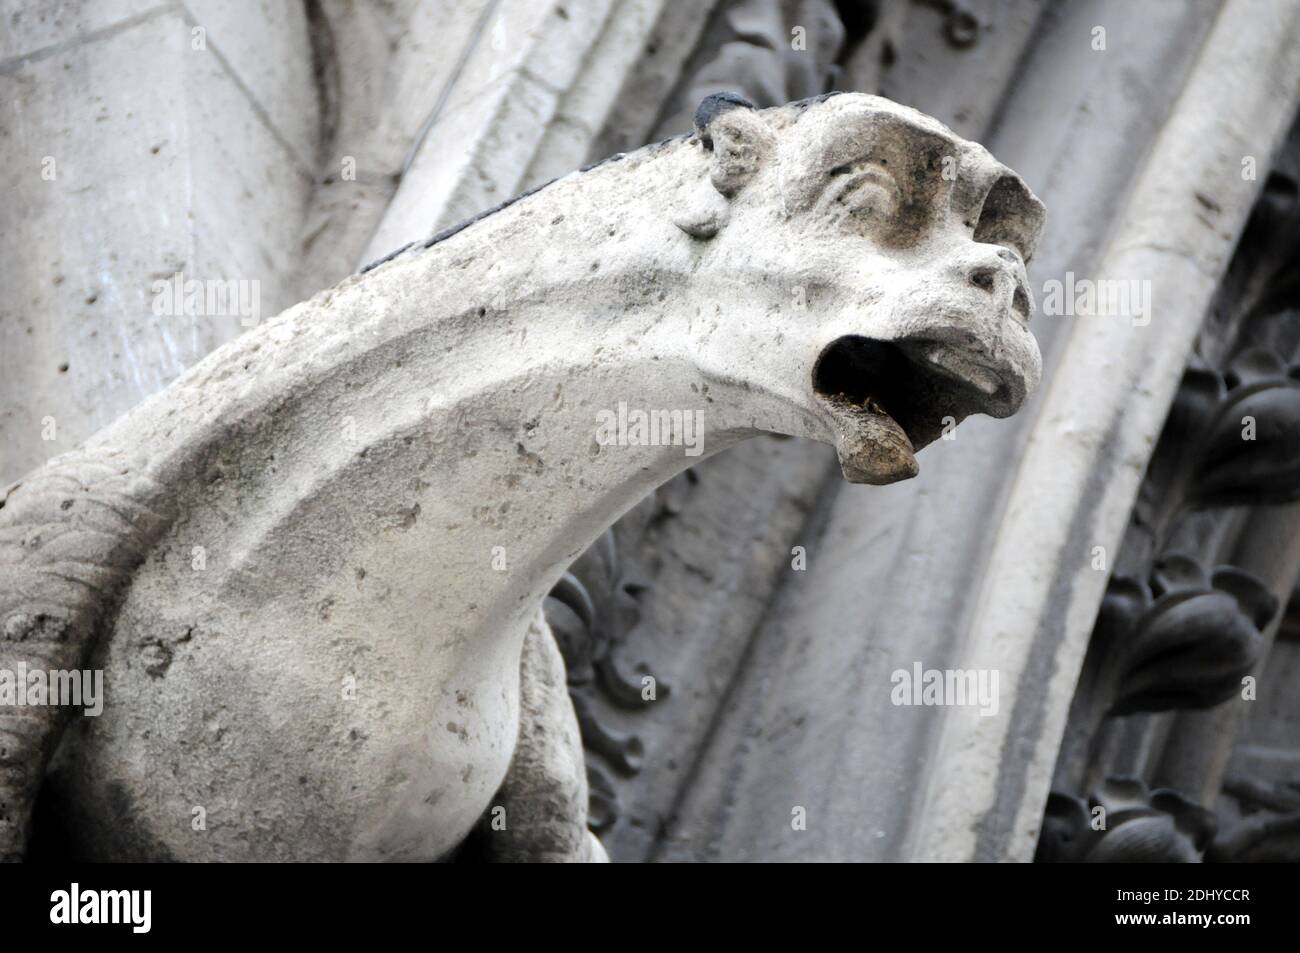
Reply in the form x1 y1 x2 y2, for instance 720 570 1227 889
91 163 789 654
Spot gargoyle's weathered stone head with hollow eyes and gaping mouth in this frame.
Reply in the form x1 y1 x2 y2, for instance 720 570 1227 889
675 94 1044 484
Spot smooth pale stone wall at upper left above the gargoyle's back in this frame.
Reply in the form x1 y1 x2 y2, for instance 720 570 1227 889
0 3 315 481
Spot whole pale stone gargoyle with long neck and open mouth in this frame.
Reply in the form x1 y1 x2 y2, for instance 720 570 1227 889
0 94 1043 861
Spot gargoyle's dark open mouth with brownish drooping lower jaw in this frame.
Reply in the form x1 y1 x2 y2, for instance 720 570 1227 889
813 335 1010 485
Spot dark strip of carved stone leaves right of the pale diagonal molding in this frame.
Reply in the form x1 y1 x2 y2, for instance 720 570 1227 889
1037 169 1300 862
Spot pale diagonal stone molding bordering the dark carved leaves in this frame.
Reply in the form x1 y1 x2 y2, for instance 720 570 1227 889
913 0 1300 859
